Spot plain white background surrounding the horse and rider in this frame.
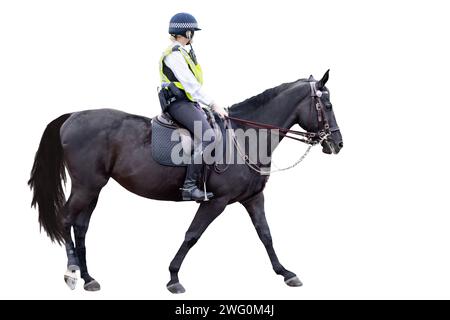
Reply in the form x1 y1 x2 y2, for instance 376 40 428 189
0 0 450 299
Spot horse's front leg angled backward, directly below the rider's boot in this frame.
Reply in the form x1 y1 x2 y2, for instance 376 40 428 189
167 198 228 293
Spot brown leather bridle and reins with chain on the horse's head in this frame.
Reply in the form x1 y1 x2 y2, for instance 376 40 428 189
221 82 339 175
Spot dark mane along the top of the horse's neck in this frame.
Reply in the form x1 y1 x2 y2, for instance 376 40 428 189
229 79 310 115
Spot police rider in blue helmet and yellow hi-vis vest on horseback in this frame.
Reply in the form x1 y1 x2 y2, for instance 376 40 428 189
160 13 227 201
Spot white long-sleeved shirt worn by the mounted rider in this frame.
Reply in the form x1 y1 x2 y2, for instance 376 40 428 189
164 41 214 106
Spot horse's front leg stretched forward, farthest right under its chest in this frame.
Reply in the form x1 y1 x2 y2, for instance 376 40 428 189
242 192 302 287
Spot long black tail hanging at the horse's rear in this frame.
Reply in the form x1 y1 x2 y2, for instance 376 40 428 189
28 113 71 244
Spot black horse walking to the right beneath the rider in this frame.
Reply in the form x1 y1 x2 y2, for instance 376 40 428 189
28 71 343 293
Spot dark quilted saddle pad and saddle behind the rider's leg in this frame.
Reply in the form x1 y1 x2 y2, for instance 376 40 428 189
151 110 221 167
